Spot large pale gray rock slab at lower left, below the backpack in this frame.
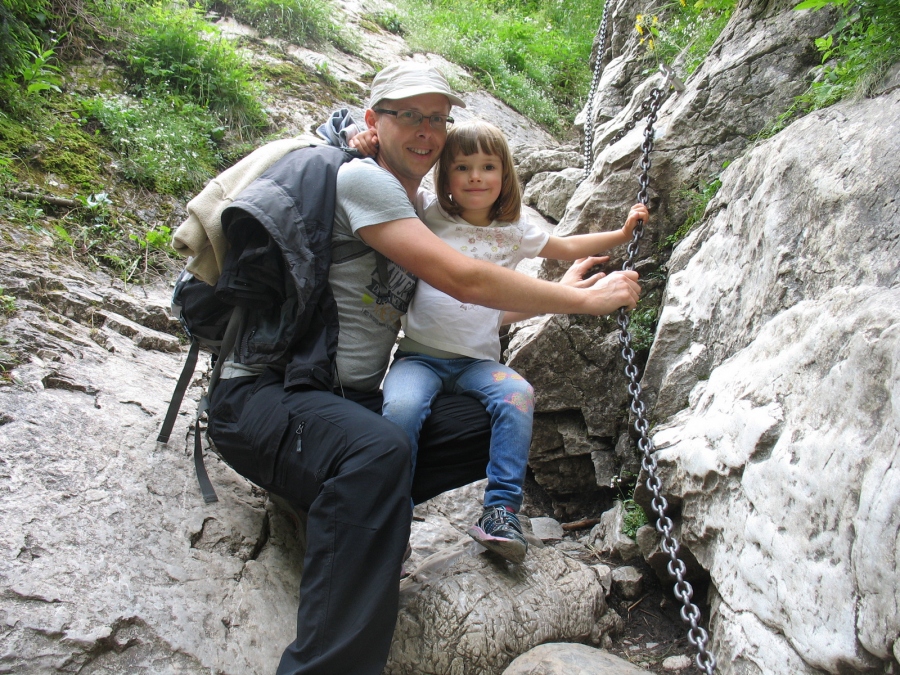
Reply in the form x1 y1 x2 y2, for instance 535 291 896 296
0 254 302 675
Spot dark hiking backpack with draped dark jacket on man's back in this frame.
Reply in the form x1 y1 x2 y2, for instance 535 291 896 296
157 140 387 503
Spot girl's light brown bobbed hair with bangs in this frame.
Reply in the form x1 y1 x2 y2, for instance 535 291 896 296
434 120 522 223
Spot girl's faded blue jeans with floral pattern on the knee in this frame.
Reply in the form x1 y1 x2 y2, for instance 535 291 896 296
382 351 534 511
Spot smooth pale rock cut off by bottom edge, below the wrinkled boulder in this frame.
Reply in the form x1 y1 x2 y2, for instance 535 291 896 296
503 643 650 675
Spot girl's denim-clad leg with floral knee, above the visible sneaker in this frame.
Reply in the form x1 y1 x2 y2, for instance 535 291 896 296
454 360 534 511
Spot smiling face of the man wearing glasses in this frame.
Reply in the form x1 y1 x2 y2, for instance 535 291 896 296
366 94 450 186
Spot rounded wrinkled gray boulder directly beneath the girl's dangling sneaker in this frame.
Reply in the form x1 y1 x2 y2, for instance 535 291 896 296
385 541 607 675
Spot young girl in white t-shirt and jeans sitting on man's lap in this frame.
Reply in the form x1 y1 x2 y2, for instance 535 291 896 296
372 121 648 563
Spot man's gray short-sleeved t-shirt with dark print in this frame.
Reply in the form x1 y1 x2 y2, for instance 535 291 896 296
328 159 418 391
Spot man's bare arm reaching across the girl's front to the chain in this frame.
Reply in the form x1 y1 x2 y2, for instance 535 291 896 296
357 218 641 316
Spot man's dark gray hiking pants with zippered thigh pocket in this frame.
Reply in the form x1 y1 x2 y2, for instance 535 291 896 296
209 372 490 675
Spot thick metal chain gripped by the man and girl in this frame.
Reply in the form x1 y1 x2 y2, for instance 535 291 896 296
611 82 716 675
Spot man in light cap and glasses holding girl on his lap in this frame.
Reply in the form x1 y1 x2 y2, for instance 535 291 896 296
209 62 640 675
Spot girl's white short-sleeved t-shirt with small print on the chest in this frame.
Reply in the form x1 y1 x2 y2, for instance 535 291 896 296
402 190 550 361
